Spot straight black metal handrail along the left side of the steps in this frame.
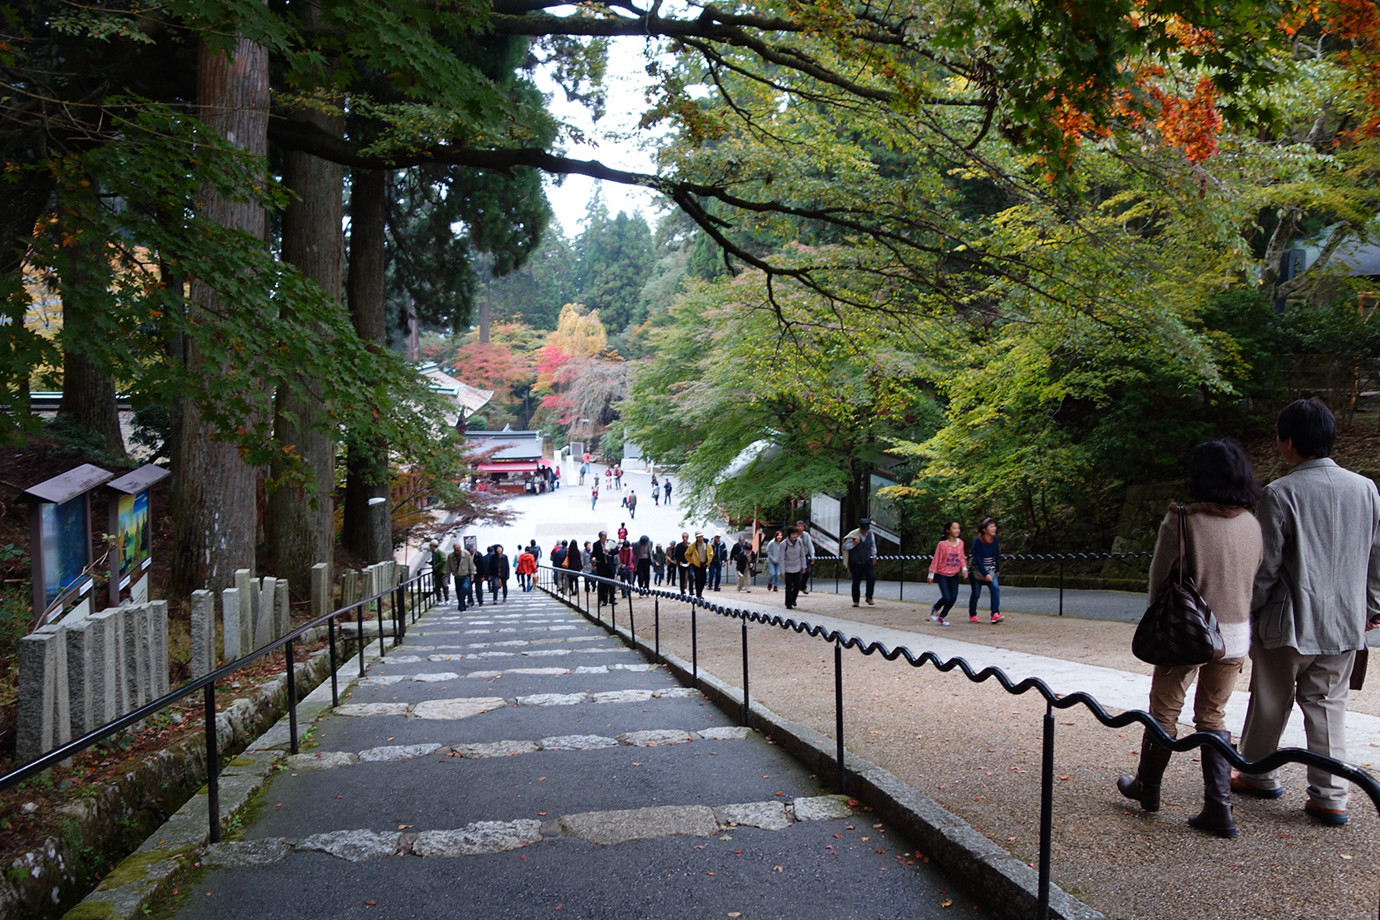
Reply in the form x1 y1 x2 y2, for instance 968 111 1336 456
0 571 436 843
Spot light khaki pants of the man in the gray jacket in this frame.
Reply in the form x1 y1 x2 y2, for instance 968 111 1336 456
1241 646 1357 808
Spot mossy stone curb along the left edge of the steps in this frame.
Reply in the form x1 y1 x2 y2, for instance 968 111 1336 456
51 637 381 920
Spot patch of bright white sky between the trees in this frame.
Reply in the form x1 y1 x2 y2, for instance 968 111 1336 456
537 39 661 236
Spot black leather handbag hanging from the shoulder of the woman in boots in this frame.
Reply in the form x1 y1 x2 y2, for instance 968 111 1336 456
1130 505 1227 668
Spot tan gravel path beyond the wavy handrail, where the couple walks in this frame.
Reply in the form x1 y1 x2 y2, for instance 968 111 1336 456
606 590 1380 920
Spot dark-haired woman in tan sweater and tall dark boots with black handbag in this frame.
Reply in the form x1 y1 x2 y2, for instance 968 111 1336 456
1116 439 1261 839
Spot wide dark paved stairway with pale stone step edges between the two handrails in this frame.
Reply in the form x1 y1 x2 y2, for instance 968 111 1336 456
164 592 988 920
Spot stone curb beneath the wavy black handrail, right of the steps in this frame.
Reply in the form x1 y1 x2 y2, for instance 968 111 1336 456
551 594 1107 920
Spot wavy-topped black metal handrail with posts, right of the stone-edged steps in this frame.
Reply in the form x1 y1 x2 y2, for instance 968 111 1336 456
540 557 1380 920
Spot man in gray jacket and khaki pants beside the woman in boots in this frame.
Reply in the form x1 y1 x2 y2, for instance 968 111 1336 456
1232 399 1380 826
